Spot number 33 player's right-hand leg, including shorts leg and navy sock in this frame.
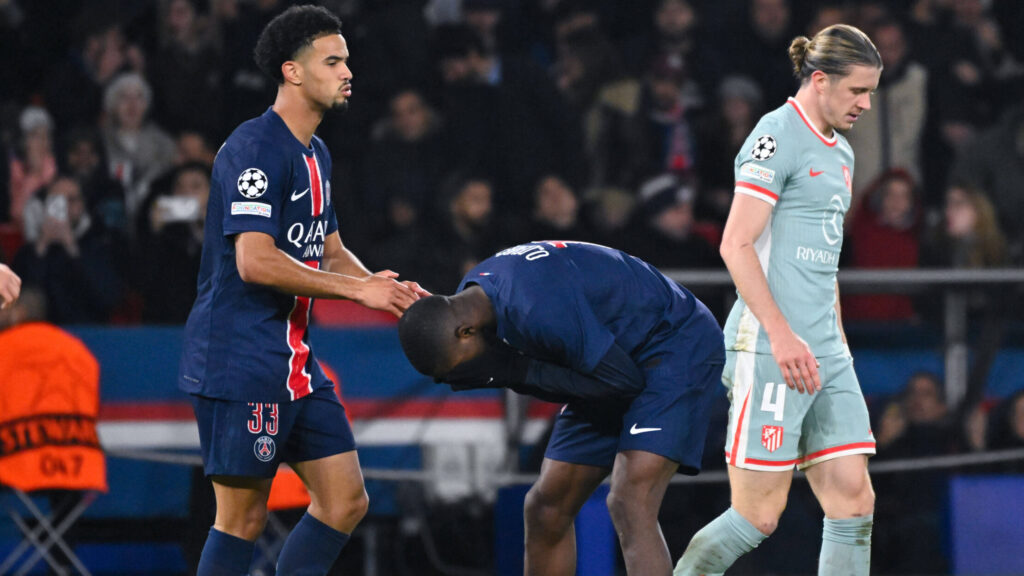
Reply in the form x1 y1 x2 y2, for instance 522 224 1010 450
278 388 370 576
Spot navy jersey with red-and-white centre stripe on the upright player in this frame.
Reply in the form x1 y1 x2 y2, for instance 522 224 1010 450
178 110 338 402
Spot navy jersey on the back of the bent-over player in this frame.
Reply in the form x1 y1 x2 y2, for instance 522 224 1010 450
459 241 722 373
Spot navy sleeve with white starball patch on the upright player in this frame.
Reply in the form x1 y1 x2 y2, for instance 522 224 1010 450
220 143 288 240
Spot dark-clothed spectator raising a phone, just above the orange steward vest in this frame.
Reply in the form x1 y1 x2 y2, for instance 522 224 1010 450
13 176 121 324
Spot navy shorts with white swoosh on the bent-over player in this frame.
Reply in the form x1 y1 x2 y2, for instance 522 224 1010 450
545 335 725 475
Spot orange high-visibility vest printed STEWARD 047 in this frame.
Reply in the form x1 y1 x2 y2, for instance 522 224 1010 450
0 323 106 492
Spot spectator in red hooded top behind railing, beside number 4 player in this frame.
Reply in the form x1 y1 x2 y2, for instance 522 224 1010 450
843 167 921 322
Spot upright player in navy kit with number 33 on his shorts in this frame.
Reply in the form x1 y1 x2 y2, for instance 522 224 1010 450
178 6 429 576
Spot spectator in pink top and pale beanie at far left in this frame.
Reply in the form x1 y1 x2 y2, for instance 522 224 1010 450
5 106 57 227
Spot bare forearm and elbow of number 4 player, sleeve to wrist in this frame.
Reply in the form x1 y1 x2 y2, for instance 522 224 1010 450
719 194 790 339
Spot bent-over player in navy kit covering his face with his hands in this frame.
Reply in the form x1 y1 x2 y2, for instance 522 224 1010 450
398 242 725 576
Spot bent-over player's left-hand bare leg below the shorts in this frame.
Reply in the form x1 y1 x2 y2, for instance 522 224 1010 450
523 458 609 576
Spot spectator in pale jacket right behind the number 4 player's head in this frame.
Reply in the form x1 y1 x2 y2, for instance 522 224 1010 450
846 19 929 196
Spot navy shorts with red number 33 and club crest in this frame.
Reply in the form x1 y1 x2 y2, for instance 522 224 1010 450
191 386 355 478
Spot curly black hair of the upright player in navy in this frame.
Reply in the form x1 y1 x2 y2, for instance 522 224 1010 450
253 5 341 84
